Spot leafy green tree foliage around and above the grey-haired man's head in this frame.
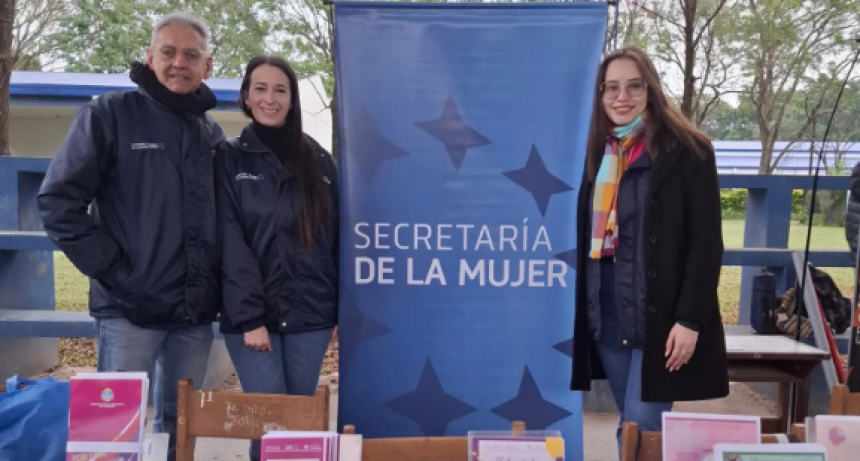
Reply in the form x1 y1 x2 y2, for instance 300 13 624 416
52 0 276 77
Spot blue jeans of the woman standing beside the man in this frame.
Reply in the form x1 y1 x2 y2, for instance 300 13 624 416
224 328 332 460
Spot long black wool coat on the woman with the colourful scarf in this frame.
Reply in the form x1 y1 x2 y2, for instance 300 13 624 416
570 145 729 402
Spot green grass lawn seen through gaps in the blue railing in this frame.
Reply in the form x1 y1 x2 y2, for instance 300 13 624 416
54 221 853 366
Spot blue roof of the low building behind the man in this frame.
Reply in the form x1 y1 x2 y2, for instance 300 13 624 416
9 70 242 104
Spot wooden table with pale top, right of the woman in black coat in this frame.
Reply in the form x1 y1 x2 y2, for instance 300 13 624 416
726 326 830 434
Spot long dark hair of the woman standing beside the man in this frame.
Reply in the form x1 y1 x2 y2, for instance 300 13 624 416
239 56 332 249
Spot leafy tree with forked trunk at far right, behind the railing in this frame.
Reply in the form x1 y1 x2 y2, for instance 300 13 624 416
732 0 860 174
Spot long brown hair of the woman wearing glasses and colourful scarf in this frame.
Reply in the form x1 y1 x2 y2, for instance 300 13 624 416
585 45 713 181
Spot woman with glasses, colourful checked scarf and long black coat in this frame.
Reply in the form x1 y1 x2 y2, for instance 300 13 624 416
571 47 729 452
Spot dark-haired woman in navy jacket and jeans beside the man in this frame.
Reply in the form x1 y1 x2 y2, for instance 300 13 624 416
216 57 338 460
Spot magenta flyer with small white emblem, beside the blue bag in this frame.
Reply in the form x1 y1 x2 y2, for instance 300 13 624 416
68 379 144 442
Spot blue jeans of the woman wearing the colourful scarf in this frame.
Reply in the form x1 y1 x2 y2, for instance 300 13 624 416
595 264 672 453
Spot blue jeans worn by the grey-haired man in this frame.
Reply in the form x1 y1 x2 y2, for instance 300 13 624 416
96 317 214 461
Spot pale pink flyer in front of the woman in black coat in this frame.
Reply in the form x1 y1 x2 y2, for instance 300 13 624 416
663 413 761 461
